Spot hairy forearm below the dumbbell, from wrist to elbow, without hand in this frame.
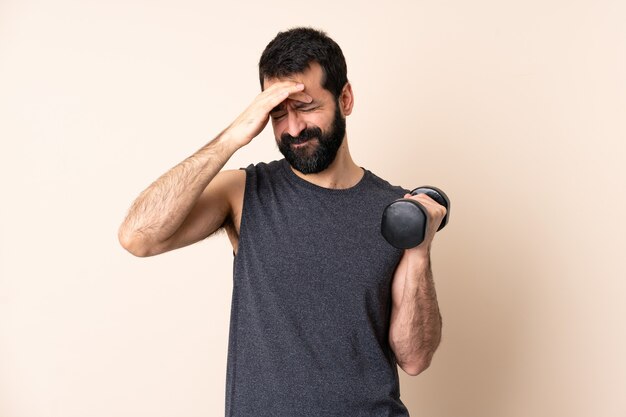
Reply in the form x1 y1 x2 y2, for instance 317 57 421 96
389 250 441 375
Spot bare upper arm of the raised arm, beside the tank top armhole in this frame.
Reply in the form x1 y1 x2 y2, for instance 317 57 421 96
152 170 246 253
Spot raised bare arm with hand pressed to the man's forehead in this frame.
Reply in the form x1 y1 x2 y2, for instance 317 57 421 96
118 81 312 256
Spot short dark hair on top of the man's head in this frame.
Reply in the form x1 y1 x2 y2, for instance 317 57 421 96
259 27 348 98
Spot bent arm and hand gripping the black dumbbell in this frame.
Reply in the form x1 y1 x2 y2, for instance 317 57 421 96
389 194 446 376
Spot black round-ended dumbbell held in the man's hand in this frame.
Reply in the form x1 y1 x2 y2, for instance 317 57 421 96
380 186 450 249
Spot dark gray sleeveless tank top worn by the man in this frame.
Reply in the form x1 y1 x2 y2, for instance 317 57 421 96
226 159 409 417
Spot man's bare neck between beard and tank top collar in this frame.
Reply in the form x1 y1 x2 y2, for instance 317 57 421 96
290 138 365 189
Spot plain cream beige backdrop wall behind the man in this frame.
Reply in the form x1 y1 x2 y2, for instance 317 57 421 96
0 0 626 417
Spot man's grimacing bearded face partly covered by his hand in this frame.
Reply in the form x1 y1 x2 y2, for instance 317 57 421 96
263 62 346 174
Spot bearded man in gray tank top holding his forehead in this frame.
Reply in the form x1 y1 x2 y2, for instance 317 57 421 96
119 28 445 417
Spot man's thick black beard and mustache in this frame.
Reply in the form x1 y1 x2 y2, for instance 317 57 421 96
277 103 346 174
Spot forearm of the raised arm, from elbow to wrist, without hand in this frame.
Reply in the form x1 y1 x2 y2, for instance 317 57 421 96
118 132 238 250
